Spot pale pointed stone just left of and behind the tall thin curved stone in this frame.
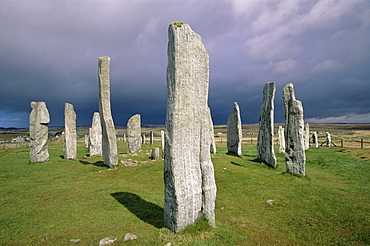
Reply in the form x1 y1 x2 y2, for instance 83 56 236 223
89 112 102 156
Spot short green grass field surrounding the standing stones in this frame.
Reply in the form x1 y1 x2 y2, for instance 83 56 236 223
0 142 370 245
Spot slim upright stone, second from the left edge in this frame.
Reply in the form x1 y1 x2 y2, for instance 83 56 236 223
64 103 77 160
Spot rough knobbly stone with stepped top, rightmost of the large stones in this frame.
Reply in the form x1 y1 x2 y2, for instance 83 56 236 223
283 83 306 176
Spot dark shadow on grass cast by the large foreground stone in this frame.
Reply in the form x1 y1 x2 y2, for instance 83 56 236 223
110 192 164 229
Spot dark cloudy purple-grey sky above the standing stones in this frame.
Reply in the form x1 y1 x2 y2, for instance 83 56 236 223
0 0 370 127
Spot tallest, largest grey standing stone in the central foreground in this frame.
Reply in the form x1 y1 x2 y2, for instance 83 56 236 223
164 22 216 232
